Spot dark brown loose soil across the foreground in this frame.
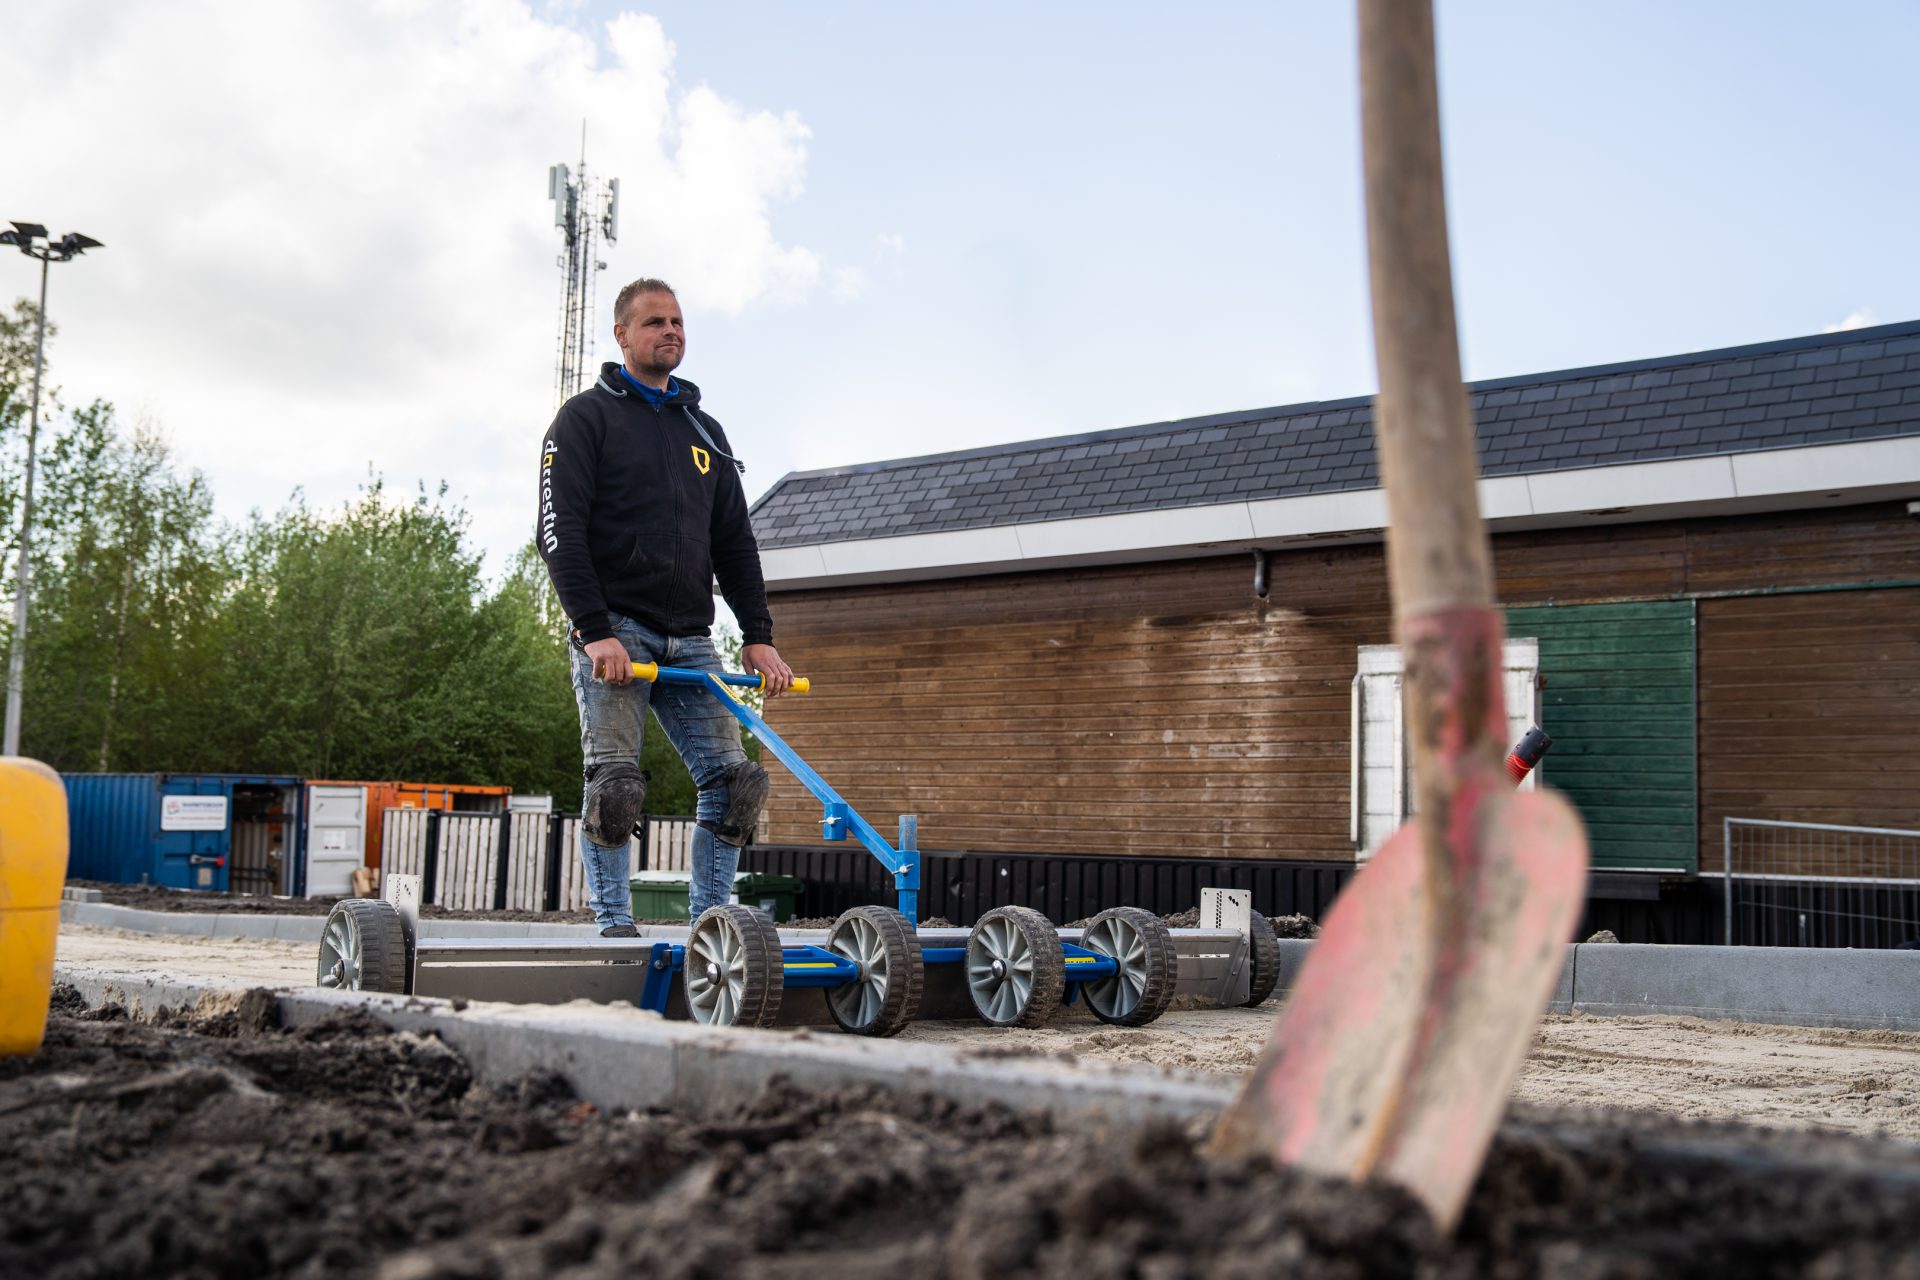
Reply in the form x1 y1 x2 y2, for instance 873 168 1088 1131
0 988 1920 1280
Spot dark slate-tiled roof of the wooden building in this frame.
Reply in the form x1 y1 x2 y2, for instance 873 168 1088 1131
753 320 1920 547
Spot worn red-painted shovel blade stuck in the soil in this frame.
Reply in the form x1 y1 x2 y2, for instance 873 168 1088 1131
1212 791 1588 1228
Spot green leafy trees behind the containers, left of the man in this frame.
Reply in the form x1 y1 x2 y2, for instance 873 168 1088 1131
0 303 739 814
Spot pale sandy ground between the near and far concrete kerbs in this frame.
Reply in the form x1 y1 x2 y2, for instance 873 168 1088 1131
60 925 1920 1138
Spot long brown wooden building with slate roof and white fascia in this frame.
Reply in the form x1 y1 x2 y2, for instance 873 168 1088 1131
755 322 1920 936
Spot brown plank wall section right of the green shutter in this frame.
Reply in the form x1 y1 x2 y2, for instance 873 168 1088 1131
1699 587 1920 875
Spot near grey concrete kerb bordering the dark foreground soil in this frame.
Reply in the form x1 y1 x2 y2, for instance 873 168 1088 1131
56 967 1236 1126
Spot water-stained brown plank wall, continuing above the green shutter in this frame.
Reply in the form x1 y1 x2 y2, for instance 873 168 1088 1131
762 503 1920 862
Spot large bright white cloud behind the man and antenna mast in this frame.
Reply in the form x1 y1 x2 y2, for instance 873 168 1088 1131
0 0 829 571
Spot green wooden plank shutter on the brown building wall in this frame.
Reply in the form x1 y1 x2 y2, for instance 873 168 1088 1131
1507 601 1699 871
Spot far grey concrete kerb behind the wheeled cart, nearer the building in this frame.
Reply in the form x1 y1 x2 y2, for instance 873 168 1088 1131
60 902 1920 1032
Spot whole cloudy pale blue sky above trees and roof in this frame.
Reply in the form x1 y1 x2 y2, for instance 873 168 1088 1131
0 0 1920 587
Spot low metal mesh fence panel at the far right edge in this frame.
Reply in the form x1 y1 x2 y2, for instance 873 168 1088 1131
1722 818 1920 948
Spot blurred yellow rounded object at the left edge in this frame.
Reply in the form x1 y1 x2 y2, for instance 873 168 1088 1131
0 756 67 1057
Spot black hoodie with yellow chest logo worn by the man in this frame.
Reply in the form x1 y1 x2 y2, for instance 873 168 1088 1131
534 363 774 645
